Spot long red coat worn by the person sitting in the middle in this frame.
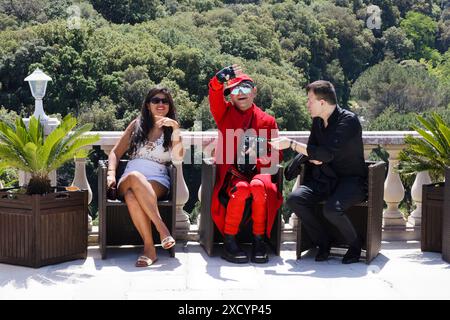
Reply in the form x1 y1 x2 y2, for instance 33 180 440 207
209 77 283 237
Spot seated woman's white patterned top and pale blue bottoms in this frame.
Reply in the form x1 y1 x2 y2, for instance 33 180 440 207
118 135 171 189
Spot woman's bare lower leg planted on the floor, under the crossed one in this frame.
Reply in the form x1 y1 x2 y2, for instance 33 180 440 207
124 189 156 261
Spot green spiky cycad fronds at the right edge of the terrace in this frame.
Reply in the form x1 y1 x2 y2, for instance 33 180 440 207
399 112 450 178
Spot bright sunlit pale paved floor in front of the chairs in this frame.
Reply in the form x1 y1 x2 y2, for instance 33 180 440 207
0 241 450 300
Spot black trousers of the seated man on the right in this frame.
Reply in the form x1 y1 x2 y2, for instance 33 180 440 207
287 177 367 247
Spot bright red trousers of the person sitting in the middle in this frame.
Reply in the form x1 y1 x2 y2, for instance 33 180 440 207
224 176 267 235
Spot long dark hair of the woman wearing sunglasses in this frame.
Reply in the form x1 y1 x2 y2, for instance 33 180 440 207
129 86 178 155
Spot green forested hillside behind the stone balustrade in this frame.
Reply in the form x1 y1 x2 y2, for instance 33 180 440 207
0 0 450 130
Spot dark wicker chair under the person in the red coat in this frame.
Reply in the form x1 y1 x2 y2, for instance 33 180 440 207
199 159 283 256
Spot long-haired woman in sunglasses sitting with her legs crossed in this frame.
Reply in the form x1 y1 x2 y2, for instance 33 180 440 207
107 87 184 267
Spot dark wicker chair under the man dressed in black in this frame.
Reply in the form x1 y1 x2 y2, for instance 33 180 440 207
296 161 386 264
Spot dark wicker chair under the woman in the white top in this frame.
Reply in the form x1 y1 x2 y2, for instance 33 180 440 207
98 160 176 259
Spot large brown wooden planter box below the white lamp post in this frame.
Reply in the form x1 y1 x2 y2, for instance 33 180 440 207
0 189 88 268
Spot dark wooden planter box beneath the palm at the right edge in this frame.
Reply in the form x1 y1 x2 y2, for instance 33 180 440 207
421 183 444 252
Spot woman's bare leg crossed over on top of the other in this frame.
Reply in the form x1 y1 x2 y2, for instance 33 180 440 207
119 172 170 239
